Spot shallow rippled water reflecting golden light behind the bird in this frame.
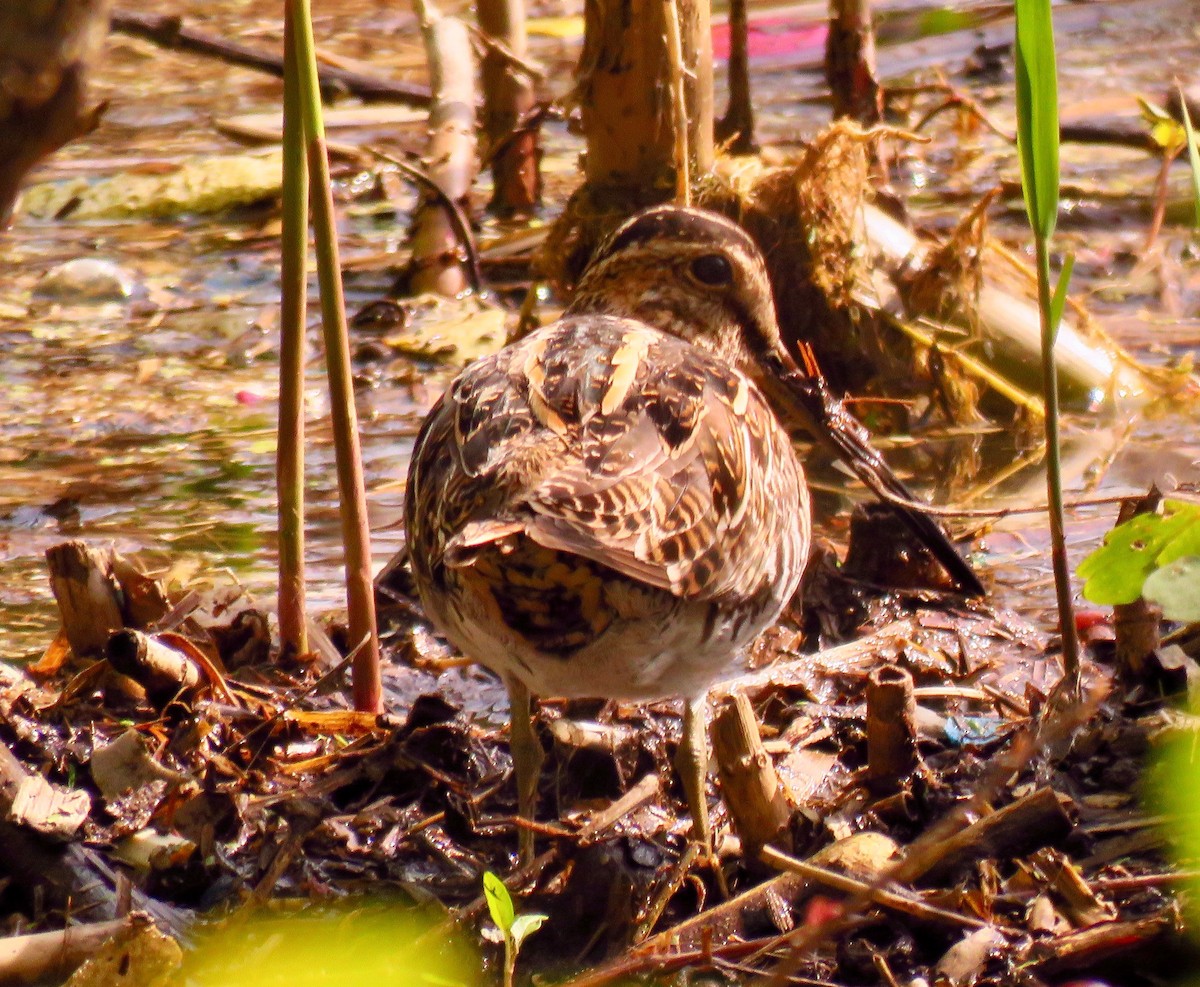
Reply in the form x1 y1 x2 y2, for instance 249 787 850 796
0 0 1200 658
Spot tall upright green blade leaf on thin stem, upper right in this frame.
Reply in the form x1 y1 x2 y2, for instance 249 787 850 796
1016 0 1058 240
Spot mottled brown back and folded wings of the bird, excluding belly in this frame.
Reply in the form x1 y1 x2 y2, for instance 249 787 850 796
409 316 808 609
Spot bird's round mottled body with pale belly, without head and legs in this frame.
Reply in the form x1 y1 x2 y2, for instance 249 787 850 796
408 315 809 699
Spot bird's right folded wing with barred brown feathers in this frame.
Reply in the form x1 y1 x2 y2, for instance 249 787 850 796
524 330 806 599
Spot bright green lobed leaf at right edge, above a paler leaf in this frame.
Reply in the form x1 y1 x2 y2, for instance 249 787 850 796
1079 501 1200 604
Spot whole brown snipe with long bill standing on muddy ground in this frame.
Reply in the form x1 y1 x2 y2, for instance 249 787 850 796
407 207 978 856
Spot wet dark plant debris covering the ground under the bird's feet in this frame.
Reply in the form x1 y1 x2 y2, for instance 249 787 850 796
0 546 1180 983
